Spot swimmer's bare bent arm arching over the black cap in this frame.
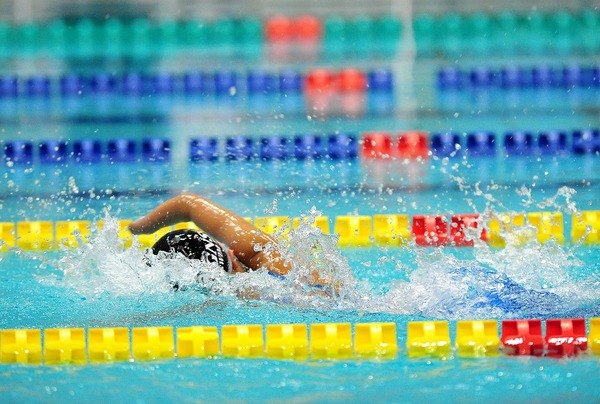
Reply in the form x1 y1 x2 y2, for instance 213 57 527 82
129 194 291 275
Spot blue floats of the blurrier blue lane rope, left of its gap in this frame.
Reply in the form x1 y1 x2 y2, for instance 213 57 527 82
0 68 393 97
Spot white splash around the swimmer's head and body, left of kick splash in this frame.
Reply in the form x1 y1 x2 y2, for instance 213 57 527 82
42 212 353 307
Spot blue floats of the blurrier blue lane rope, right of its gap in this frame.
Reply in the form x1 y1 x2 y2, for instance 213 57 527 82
437 65 600 89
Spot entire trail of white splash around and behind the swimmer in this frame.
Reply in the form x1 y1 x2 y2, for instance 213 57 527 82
38 204 599 319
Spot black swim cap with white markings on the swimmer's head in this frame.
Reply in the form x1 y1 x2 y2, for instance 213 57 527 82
152 229 231 272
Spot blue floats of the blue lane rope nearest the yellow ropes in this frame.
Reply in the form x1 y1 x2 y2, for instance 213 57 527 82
3 129 600 164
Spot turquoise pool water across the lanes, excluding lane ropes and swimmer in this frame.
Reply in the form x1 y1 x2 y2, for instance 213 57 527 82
0 7 600 402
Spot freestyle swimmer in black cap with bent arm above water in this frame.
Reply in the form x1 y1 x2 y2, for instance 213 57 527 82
129 194 298 280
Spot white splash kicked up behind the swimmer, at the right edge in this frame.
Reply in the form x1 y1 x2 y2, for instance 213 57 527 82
368 237 599 319
